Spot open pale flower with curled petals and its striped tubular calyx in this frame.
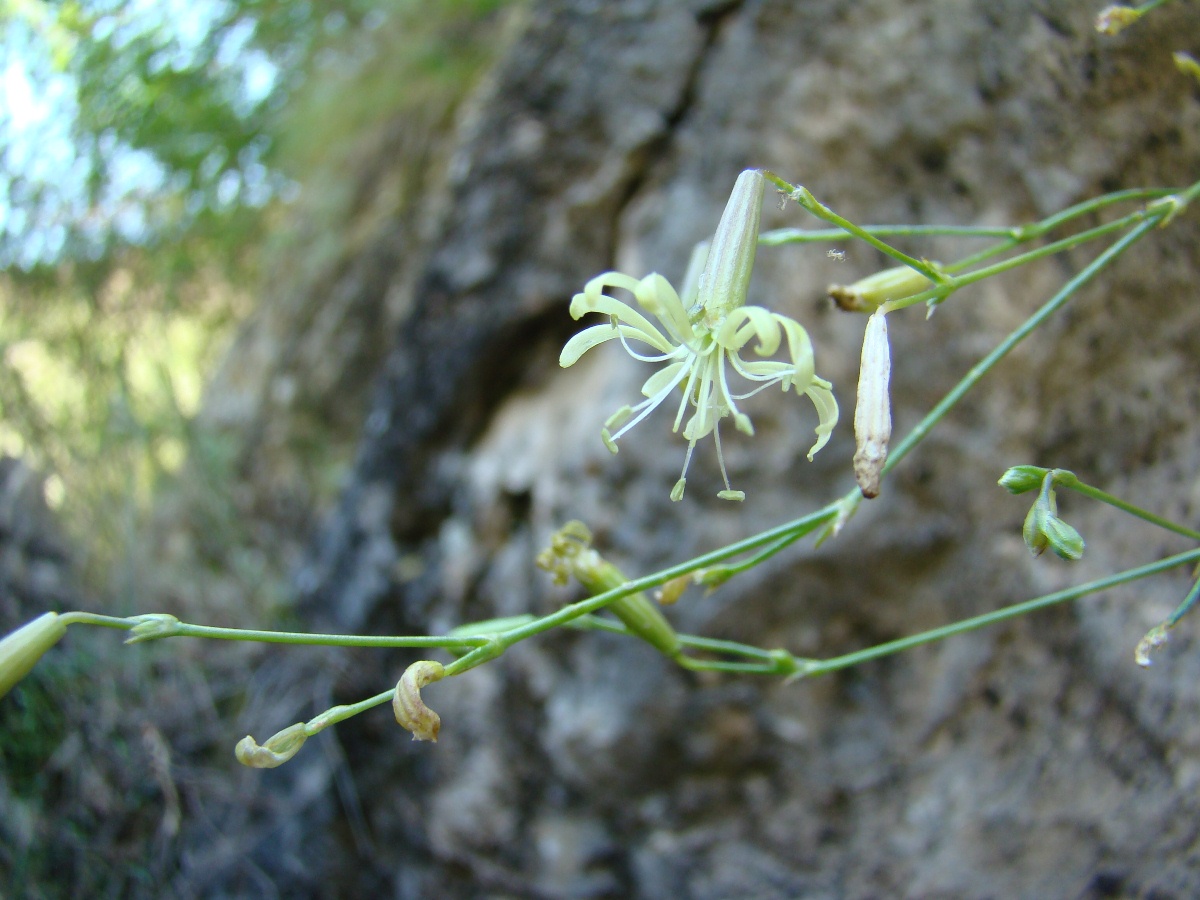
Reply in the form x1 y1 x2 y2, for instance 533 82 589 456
558 169 838 500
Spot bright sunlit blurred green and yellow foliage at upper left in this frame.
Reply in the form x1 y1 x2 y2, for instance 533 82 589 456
0 0 516 583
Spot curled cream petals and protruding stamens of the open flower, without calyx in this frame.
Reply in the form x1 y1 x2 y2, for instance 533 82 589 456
558 255 838 500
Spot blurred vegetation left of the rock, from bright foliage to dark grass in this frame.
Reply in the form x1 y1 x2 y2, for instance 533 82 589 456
0 0 518 896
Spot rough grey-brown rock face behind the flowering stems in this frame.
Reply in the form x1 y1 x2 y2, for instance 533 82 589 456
283 0 1200 899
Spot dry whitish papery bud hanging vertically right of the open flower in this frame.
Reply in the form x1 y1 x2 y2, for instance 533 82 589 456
854 310 892 497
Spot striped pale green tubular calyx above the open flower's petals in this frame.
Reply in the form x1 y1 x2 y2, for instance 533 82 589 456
696 169 766 326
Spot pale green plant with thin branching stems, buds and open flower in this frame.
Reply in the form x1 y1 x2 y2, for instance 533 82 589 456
0 0 1200 768
